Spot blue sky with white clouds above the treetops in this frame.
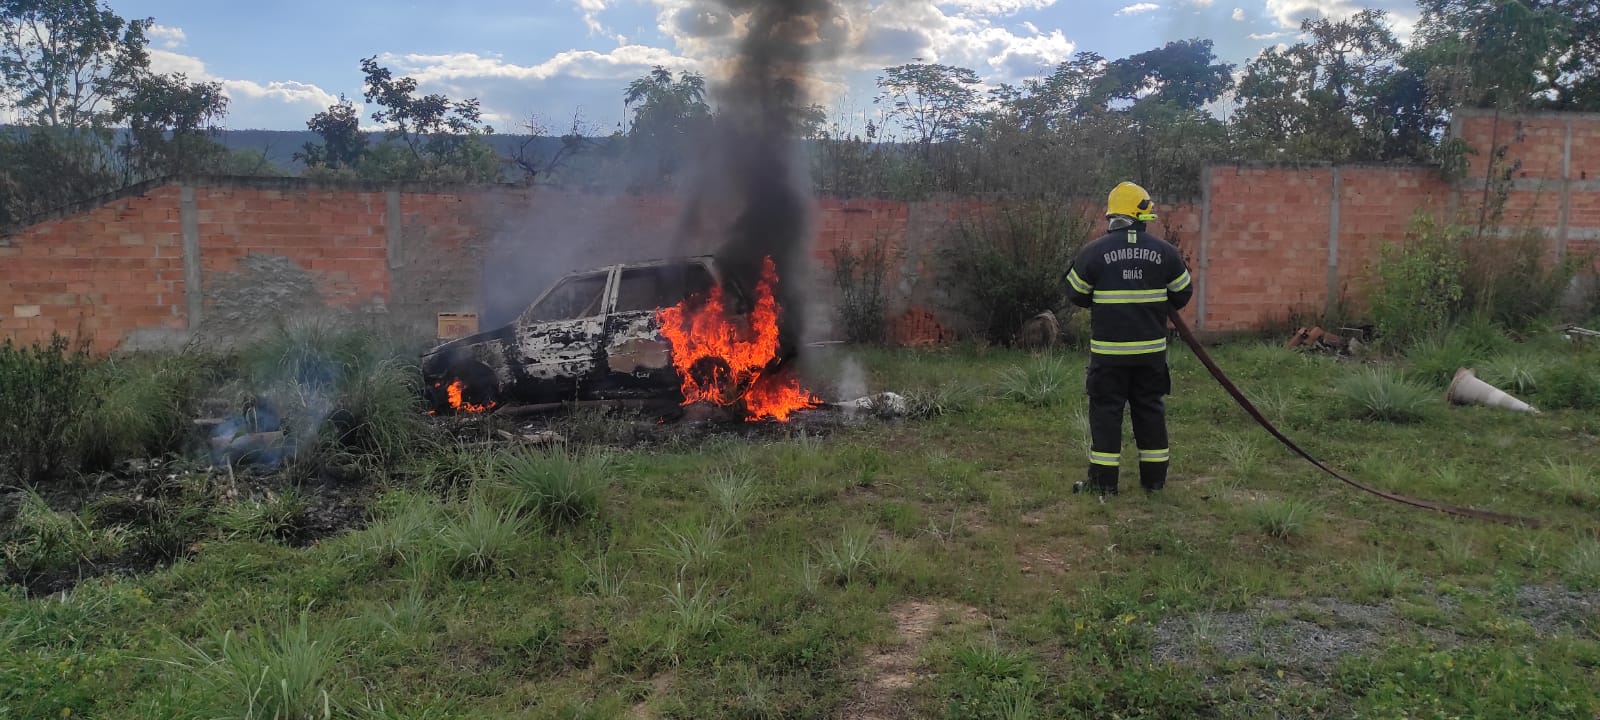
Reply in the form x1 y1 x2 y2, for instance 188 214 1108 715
109 0 1416 133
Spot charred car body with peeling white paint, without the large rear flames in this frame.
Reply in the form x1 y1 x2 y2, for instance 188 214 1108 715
421 256 750 411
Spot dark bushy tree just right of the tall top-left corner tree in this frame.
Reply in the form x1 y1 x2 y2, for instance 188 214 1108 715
110 74 227 179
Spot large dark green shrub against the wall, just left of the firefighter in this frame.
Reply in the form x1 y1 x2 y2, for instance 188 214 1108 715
946 202 1090 346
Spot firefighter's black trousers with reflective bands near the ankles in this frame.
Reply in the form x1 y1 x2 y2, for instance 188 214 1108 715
1083 362 1173 491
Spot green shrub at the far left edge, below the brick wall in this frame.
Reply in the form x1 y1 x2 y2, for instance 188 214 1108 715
0 334 98 483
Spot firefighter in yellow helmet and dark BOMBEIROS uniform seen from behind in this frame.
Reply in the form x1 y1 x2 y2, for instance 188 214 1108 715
1062 182 1194 498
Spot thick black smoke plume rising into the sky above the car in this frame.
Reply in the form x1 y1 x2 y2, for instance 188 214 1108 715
682 0 848 360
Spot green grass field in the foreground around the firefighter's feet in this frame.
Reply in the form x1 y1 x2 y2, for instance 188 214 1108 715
0 328 1600 720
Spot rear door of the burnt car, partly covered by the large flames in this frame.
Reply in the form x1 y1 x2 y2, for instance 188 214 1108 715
605 259 717 397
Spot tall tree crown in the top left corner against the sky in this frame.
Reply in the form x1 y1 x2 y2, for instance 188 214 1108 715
0 0 154 130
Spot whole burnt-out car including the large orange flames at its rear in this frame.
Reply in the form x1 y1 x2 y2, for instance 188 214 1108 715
421 256 819 421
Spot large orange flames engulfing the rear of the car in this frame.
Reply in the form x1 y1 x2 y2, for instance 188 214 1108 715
656 258 822 422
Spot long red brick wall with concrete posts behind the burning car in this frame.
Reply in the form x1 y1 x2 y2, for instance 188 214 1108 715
0 114 1600 350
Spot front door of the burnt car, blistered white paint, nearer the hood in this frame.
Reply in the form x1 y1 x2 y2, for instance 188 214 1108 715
515 266 618 395
